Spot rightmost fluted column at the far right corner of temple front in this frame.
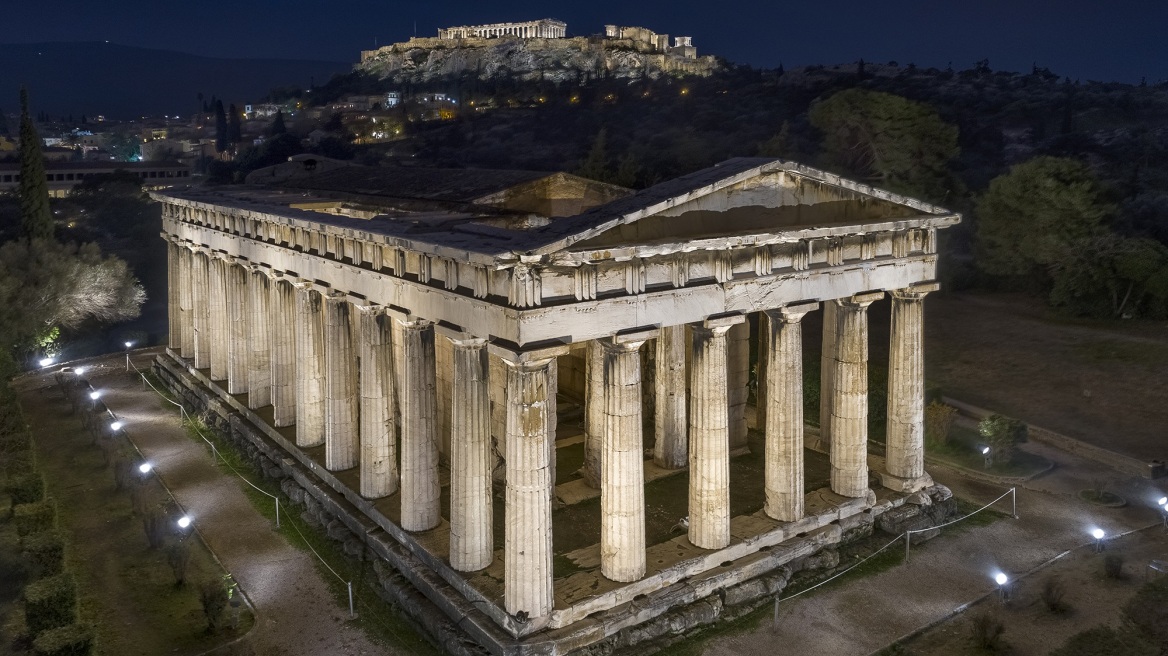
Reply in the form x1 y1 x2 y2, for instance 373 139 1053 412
882 282 939 491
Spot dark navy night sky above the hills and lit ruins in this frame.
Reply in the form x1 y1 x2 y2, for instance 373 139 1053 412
0 0 1168 82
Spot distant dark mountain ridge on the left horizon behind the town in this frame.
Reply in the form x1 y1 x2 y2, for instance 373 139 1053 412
0 42 353 119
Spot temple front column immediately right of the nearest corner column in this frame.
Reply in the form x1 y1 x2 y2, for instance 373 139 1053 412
598 335 646 582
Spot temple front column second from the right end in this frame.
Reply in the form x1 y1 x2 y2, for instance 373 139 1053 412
830 292 884 497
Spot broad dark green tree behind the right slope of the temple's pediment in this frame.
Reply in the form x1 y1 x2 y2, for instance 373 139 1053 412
808 89 959 201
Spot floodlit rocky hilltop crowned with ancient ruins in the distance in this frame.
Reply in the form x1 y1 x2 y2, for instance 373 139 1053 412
357 19 721 83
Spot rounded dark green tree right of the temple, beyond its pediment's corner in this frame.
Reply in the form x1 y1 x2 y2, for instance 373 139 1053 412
976 156 1112 281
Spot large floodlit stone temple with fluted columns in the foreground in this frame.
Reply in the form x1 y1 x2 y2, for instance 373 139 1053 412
154 159 960 654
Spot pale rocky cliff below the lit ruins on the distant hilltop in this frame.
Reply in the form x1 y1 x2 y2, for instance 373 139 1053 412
357 37 719 83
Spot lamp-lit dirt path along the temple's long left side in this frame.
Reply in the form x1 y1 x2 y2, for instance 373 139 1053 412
20 351 392 656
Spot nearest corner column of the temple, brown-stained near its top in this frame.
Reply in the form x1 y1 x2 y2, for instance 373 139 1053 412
503 357 555 617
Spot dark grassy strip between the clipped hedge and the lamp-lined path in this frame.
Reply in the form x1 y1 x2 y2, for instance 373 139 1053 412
21 380 252 656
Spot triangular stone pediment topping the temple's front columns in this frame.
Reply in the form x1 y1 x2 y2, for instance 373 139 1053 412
533 159 951 254
